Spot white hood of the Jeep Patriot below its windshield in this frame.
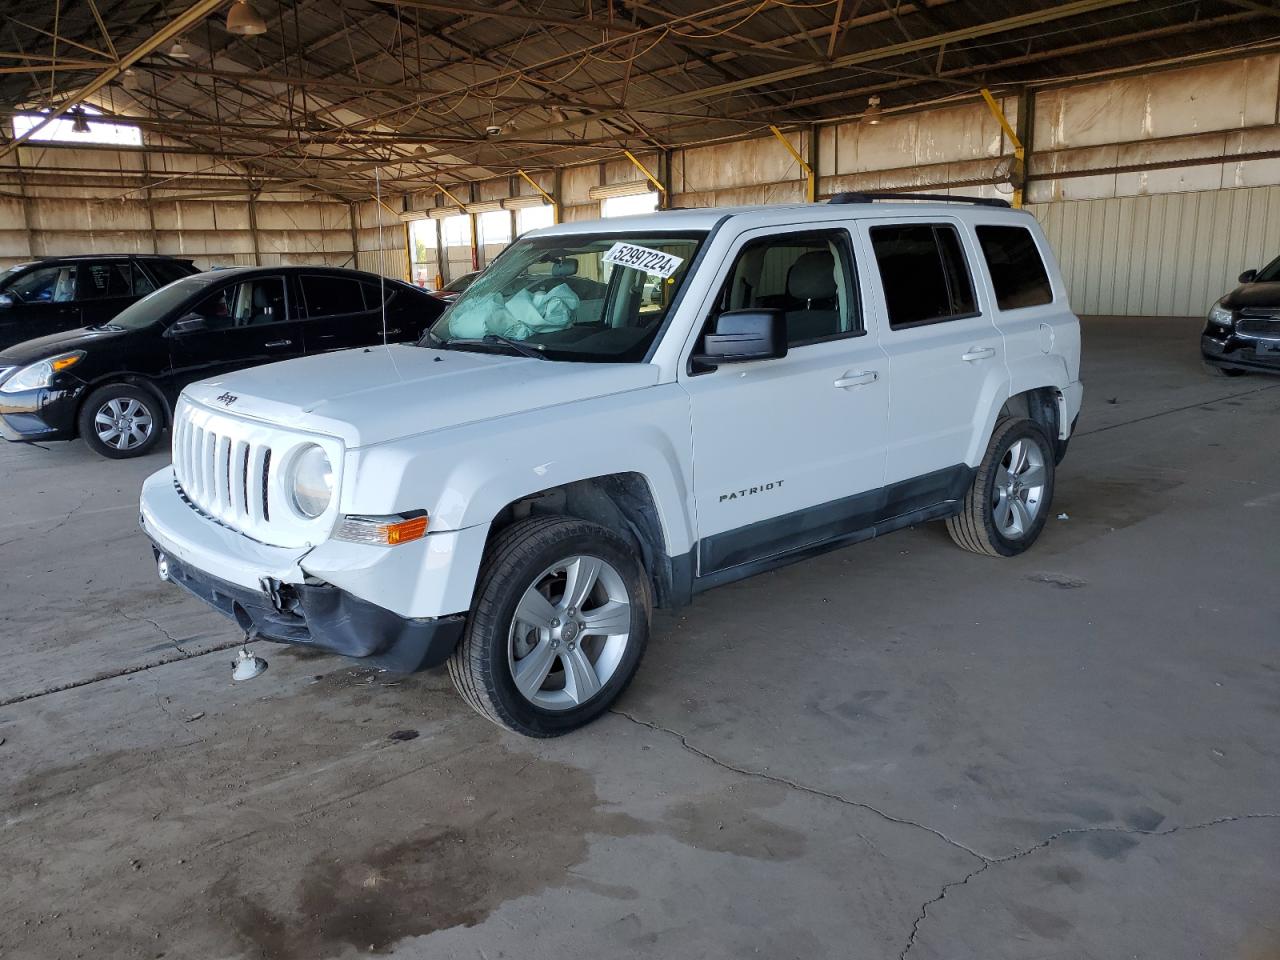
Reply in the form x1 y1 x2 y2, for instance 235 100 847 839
186 346 658 448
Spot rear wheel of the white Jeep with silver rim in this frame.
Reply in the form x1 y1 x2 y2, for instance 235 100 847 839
947 417 1055 557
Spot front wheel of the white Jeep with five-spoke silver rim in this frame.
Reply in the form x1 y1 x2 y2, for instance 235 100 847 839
449 517 652 737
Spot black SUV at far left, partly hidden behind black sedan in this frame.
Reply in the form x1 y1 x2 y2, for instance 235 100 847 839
0 253 196 349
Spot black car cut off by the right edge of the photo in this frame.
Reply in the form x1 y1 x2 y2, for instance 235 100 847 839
1201 257 1280 376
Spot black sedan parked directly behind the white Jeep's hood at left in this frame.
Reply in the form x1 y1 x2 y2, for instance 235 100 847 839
0 266 445 460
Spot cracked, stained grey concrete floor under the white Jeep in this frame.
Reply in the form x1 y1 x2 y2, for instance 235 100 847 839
0 319 1280 960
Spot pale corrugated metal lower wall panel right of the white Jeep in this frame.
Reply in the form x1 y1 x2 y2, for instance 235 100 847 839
1028 187 1280 316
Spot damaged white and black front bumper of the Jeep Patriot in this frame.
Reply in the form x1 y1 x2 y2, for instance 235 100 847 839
140 470 465 672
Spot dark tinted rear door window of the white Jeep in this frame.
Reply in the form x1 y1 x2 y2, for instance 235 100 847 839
870 224 977 330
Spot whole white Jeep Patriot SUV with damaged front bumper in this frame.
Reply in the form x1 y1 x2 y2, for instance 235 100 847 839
142 195 1082 736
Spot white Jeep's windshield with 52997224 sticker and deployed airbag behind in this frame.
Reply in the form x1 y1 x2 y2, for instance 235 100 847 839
424 233 707 364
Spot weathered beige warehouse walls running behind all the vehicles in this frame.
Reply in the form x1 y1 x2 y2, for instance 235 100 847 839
10 54 1280 315
